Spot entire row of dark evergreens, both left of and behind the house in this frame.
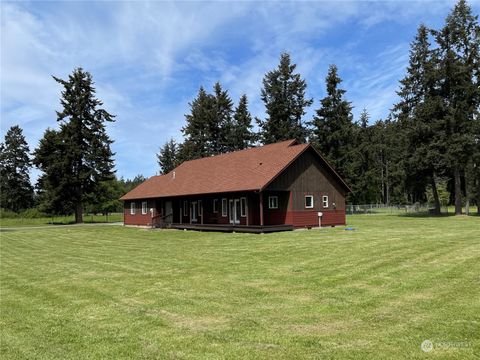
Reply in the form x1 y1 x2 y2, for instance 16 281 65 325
0 0 480 222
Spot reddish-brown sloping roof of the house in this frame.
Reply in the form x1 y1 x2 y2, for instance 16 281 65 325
121 140 348 200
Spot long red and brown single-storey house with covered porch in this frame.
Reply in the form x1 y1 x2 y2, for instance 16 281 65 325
121 140 350 232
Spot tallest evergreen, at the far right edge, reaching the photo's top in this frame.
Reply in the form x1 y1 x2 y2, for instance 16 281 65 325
435 0 480 214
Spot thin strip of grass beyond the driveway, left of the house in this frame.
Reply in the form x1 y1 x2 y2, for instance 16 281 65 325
0 214 123 227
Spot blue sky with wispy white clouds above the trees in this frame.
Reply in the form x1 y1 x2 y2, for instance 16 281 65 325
1 1 480 178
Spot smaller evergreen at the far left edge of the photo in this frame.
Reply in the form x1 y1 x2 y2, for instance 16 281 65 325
0 125 33 212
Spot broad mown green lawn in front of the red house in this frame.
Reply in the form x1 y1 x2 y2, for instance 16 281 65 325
0 215 480 359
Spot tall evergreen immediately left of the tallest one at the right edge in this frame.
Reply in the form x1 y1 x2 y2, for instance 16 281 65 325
394 25 444 214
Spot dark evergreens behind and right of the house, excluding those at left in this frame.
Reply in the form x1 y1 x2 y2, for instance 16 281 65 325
157 0 480 214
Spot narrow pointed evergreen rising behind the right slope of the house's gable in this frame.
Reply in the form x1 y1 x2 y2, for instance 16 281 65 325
311 65 357 184
